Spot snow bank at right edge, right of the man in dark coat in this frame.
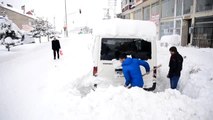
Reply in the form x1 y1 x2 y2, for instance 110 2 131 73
180 48 213 99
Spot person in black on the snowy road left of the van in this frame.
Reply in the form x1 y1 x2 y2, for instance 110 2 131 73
52 37 61 60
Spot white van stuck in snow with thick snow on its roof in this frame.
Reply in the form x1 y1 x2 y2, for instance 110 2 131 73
93 19 157 87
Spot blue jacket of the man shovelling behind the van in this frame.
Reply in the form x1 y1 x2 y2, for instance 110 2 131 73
122 58 150 87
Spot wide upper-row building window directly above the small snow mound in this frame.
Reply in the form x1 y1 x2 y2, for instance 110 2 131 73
161 0 175 18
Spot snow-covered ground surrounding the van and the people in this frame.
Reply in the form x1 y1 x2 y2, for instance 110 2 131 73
0 35 213 120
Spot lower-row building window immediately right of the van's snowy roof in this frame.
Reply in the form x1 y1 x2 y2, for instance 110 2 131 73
160 21 174 37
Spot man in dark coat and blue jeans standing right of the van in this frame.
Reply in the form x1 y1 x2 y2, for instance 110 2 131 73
167 46 183 89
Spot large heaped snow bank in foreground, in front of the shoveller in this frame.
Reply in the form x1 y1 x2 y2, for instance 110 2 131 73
70 86 203 120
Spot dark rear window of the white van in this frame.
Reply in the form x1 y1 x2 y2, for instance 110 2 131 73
101 38 152 60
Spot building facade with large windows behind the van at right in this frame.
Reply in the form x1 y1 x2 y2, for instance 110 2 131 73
121 0 213 48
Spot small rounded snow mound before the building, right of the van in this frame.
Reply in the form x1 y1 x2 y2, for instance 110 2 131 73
160 35 181 47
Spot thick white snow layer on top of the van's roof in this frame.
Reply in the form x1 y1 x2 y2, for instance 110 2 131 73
93 18 156 40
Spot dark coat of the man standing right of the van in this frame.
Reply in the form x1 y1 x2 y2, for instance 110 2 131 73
168 52 183 78
